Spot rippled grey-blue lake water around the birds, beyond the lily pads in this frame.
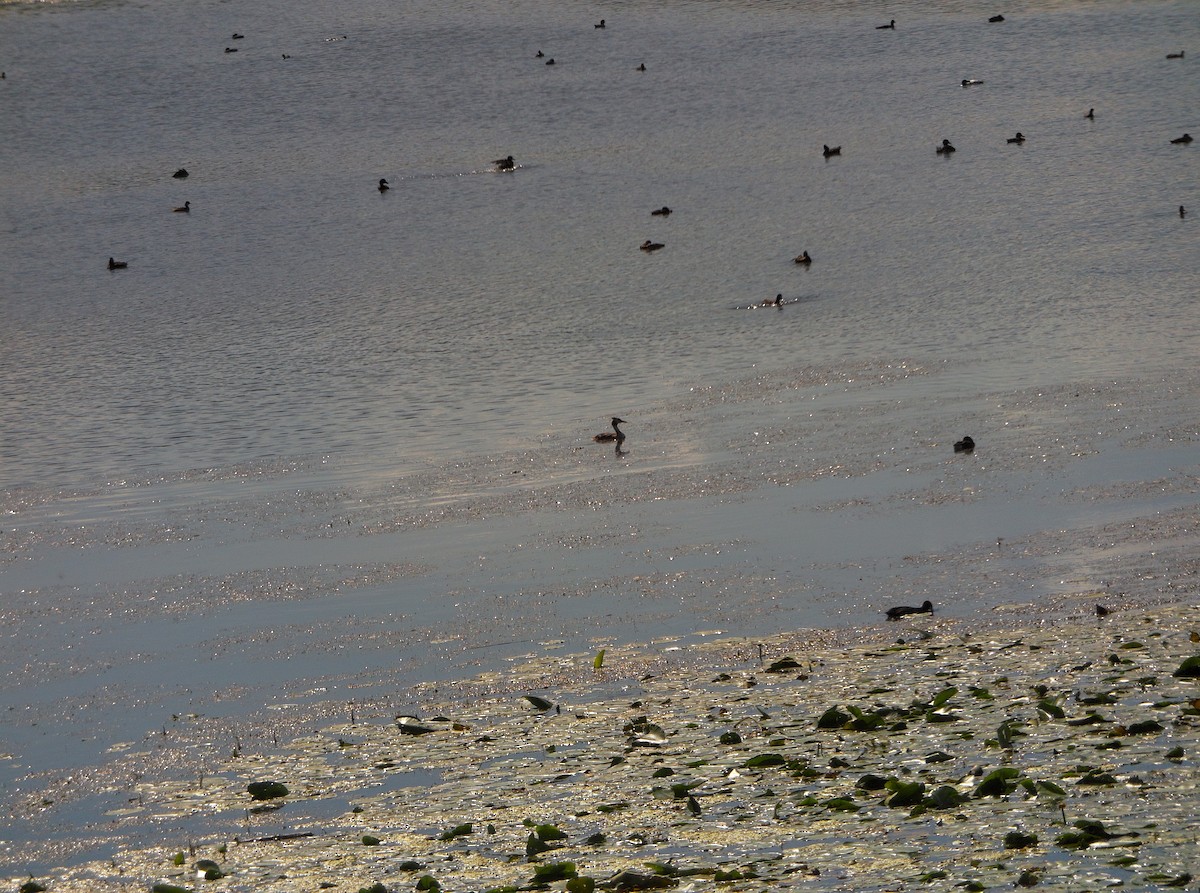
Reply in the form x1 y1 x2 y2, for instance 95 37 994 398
0 0 1200 868
